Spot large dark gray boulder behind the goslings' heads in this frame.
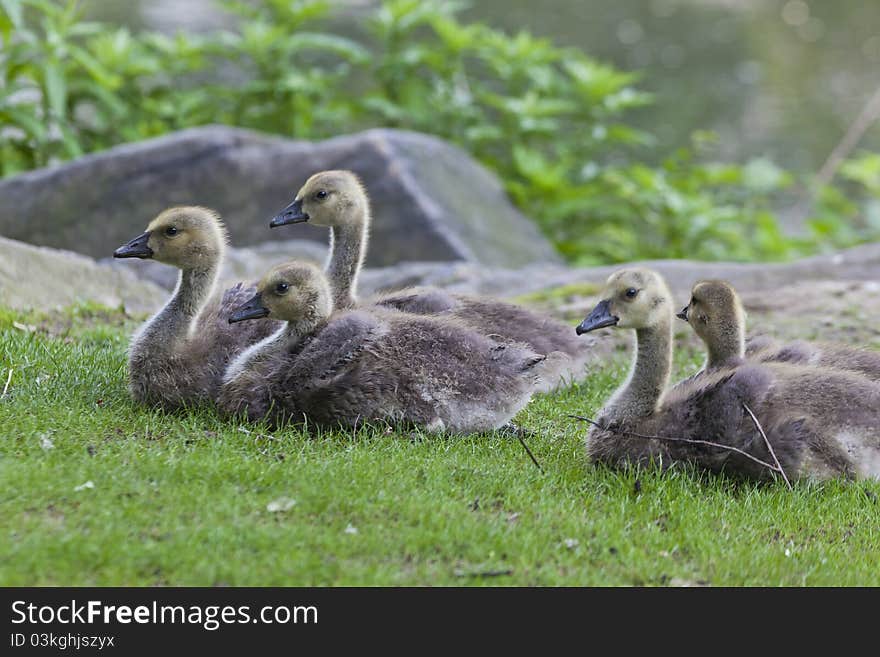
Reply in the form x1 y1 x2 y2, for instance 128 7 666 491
0 126 558 267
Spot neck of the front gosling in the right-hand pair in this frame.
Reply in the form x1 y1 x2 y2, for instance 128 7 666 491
606 315 672 420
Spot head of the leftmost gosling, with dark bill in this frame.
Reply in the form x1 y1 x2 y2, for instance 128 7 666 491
113 206 226 269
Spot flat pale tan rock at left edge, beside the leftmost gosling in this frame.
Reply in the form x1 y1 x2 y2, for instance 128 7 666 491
0 237 168 314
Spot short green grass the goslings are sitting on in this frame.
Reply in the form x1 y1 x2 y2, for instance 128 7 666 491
0 307 880 586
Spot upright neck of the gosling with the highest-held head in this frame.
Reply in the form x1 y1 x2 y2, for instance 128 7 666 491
326 203 370 309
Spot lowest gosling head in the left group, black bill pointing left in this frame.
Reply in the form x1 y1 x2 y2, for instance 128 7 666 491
229 262 333 327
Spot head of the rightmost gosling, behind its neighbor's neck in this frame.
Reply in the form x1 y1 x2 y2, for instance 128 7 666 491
676 280 746 354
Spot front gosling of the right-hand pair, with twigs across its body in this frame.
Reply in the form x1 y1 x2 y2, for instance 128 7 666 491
577 269 880 480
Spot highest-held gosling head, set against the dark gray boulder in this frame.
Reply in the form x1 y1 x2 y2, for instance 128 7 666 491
269 170 367 228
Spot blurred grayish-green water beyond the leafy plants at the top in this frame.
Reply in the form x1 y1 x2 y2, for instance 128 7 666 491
86 0 880 171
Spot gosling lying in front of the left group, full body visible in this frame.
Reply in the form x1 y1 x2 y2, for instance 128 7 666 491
219 263 545 433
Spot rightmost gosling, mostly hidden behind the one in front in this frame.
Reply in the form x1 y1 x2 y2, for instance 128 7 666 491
677 280 880 382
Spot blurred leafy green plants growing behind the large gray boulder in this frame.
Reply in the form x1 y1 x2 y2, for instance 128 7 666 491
0 0 880 264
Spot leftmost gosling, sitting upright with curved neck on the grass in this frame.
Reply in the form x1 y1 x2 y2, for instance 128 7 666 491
113 207 279 409
